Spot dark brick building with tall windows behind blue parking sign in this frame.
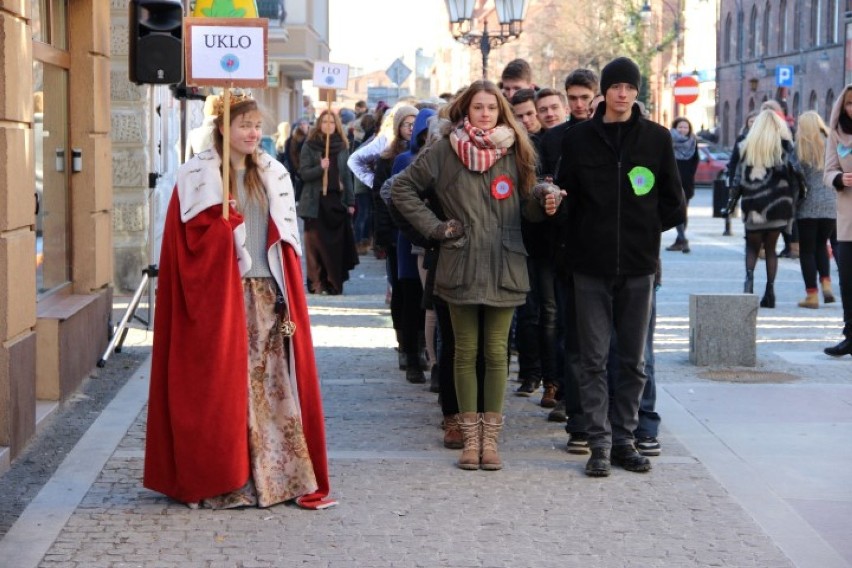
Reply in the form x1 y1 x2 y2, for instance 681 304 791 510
716 0 850 146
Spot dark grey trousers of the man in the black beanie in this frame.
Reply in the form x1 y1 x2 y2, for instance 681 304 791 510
574 273 654 448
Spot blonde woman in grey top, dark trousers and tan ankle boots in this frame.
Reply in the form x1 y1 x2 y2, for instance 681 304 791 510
796 110 837 308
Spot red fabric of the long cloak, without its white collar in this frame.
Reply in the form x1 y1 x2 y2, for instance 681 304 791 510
143 191 335 509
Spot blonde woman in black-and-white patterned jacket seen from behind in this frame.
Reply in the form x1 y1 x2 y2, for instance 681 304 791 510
728 109 799 308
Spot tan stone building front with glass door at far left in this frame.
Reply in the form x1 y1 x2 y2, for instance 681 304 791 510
0 0 114 468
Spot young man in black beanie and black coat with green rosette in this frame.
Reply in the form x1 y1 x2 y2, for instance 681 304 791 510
545 57 686 477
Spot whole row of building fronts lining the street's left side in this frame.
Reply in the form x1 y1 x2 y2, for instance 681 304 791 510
0 0 328 471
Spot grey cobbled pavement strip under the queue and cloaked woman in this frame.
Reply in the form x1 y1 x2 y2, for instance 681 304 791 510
0 192 848 568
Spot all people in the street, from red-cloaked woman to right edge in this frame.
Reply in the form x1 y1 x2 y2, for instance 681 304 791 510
145 57 852 508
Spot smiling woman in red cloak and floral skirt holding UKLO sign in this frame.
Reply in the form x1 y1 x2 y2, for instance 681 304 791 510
144 95 334 509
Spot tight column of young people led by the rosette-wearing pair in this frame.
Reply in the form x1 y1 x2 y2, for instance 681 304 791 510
303 58 684 476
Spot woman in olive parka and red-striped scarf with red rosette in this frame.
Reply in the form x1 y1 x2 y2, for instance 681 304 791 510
391 80 536 470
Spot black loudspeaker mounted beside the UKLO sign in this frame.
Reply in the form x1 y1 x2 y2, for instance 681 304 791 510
129 0 183 85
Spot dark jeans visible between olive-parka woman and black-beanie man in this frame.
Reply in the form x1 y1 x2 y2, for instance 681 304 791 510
515 258 557 382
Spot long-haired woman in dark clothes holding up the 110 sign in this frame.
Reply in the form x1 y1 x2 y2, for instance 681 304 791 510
296 110 358 295
